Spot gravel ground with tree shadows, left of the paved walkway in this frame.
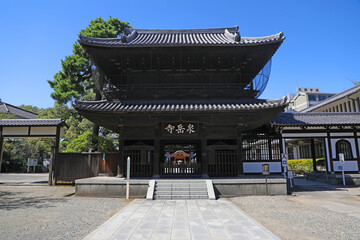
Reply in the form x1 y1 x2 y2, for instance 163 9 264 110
0 185 129 240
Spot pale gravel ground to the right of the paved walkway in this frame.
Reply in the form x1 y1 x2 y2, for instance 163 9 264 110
231 188 360 239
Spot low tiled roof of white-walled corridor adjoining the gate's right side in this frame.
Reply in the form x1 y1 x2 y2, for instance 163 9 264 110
270 112 360 126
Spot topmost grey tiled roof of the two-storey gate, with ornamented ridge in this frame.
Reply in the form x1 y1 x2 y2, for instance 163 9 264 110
79 26 285 47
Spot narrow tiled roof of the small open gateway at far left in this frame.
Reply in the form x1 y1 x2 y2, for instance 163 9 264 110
0 119 65 127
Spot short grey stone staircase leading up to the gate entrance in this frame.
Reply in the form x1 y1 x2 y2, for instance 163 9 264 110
149 180 215 200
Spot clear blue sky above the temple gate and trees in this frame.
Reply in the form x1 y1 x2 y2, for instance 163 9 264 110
0 0 360 108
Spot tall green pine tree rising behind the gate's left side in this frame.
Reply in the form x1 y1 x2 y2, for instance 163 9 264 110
48 16 130 148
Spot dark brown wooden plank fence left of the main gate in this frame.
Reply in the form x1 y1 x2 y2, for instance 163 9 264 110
53 153 119 183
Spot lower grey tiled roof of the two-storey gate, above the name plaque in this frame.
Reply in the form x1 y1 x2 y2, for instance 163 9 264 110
73 98 287 112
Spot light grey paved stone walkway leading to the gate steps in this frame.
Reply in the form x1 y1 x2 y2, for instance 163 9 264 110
85 199 279 240
